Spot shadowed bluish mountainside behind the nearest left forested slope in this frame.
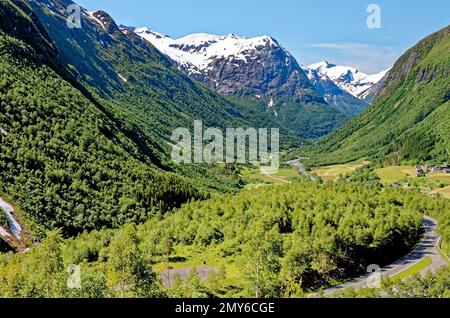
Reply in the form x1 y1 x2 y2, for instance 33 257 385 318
26 0 282 134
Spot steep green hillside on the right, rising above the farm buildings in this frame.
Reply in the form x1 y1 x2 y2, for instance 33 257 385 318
305 26 450 163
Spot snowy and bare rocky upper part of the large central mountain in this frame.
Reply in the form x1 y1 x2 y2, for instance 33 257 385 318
135 28 325 104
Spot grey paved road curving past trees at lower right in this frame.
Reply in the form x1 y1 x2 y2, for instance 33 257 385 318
324 216 448 295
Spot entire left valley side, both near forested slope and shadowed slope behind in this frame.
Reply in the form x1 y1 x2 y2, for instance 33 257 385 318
0 0 300 234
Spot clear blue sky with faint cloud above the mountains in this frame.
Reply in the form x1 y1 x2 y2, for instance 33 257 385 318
75 0 450 73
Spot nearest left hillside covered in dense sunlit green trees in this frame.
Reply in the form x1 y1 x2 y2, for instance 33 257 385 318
0 35 206 232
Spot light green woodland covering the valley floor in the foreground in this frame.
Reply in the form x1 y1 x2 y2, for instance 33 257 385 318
0 182 450 297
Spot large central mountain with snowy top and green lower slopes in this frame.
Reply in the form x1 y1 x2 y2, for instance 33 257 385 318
134 27 384 139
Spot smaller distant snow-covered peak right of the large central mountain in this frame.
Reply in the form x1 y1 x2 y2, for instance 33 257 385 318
308 62 389 99
